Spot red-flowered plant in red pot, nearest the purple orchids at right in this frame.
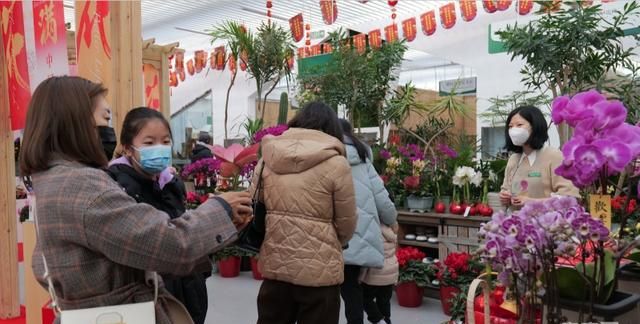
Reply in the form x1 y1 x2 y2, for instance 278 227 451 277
433 252 484 320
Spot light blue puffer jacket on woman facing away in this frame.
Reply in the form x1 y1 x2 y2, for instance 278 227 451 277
344 137 398 268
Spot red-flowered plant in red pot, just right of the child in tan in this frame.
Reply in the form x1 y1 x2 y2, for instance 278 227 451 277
396 247 433 307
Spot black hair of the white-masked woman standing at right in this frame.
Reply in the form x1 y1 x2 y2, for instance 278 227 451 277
504 106 549 153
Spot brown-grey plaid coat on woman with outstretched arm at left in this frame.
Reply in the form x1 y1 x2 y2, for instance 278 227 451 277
32 160 236 324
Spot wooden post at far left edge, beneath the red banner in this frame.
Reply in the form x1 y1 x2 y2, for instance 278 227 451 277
0 22 20 319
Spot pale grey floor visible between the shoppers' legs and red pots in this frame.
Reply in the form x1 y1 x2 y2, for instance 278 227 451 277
206 272 448 324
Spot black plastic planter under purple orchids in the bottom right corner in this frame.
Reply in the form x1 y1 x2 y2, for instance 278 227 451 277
560 291 640 323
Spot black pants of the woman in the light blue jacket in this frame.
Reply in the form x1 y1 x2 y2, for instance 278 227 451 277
340 265 364 324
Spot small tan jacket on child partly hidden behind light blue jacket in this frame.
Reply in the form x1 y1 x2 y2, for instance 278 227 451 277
360 224 399 286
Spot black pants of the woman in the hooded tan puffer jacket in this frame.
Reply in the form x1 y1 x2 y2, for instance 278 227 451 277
258 280 340 324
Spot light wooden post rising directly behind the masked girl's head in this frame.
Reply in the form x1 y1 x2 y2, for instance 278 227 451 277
109 1 144 140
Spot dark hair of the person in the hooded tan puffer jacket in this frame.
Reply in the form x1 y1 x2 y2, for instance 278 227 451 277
289 102 343 142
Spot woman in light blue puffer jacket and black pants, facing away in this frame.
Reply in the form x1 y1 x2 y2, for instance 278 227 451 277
340 119 398 324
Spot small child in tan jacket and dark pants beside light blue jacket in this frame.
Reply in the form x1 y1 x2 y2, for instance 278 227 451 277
360 224 399 324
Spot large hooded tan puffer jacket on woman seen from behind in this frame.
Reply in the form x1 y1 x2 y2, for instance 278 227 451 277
251 128 357 287
